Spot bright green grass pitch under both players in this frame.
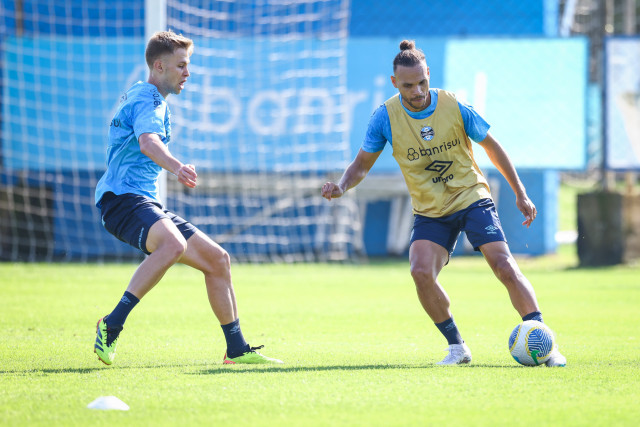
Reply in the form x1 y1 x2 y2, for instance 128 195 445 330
0 249 640 426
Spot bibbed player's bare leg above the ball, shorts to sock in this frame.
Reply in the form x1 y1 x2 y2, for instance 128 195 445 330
480 242 540 317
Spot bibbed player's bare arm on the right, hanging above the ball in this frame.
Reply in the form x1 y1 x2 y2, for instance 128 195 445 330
478 132 538 227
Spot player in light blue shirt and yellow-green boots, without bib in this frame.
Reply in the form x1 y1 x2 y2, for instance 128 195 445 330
94 31 282 365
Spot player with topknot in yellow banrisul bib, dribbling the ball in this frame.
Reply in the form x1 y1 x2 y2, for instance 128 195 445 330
322 40 566 366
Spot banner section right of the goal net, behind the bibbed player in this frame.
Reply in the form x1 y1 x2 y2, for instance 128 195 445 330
348 38 588 173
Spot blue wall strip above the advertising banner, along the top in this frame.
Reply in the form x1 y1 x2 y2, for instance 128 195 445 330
0 0 558 38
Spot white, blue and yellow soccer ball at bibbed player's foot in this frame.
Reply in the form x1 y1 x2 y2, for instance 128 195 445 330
509 320 556 366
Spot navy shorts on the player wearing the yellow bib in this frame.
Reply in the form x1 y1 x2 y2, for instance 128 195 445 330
411 199 507 255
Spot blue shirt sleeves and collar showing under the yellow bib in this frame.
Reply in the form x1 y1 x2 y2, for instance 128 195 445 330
362 89 490 153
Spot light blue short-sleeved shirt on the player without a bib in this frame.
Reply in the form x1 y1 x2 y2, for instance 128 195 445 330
95 82 171 208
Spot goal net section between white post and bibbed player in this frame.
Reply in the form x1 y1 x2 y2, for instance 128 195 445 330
167 0 358 261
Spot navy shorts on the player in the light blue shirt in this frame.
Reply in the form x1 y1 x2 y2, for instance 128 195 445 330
100 192 196 255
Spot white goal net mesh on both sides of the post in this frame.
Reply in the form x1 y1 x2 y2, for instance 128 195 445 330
0 0 360 261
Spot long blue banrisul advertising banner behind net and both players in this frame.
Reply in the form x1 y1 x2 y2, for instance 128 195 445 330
2 37 588 173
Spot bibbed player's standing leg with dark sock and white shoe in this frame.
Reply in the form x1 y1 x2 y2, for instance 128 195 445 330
409 240 471 365
